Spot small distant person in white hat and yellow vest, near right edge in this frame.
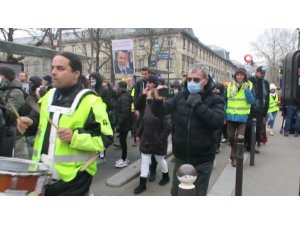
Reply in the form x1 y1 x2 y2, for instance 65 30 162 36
268 83 279 136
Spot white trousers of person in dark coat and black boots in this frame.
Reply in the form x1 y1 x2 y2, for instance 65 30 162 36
140 153 168 177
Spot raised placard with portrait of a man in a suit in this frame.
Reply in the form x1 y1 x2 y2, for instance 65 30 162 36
112 39 134 74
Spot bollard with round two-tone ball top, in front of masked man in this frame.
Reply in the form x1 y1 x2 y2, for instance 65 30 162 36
176 164 197 196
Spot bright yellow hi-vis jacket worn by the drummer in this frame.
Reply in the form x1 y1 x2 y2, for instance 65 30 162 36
32 88 113 182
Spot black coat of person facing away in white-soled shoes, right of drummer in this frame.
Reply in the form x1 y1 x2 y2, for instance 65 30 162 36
116 91 132 132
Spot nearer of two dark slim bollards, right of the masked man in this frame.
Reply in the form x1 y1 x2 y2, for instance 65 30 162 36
235 135 245 196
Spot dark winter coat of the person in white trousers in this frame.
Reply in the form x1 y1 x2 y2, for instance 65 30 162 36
137 104 172 155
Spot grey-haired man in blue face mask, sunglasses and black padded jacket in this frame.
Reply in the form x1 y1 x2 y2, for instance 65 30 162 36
151 64 225 195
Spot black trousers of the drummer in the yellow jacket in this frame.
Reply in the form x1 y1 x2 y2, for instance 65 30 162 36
44 171 93 196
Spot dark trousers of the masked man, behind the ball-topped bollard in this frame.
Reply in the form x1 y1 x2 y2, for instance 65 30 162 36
171 158 214 196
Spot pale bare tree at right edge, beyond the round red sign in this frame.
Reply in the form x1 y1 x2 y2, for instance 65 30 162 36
251 28 297 83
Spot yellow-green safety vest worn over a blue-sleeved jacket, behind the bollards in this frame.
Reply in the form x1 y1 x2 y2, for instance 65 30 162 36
226 81 253 115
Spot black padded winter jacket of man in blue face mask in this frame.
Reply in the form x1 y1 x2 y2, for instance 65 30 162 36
152 80 225 166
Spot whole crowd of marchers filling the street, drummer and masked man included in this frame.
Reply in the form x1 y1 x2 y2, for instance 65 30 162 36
0 52 300 196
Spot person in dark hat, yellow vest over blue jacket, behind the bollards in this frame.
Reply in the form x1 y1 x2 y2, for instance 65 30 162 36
225 68 254 167
